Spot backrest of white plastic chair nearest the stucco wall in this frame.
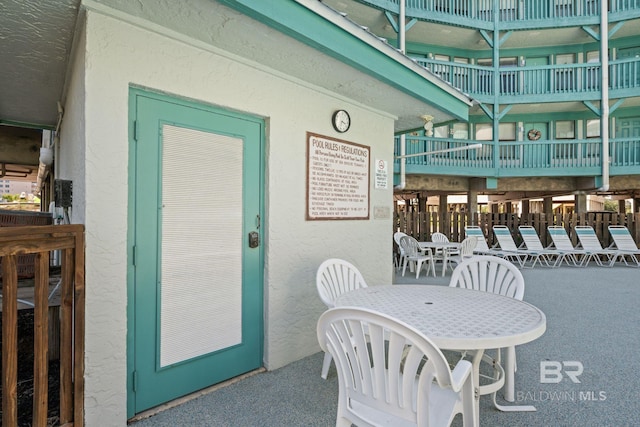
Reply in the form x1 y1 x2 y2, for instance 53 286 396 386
316 258 367 308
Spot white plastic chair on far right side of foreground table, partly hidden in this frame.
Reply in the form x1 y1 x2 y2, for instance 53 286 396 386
449 255 524 403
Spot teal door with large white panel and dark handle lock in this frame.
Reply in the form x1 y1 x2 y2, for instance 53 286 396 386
127 89 264 416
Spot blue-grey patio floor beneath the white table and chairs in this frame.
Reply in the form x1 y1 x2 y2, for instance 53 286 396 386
132 265 640 427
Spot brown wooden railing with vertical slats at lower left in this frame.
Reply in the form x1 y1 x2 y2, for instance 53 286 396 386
0 225 85 427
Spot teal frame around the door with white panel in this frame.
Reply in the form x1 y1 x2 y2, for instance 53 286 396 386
126 85 266 418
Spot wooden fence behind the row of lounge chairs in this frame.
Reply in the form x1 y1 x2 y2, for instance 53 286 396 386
393 212 640 247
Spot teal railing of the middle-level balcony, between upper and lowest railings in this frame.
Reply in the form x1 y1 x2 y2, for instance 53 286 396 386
416 58 640 104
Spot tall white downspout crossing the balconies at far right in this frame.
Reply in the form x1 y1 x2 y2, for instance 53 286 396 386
600 1 609 191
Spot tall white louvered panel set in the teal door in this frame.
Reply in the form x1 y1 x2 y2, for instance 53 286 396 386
159 125 243 367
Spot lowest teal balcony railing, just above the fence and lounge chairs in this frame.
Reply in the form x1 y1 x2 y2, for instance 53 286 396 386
395 136 640 177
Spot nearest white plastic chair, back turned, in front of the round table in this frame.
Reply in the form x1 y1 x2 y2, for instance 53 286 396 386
317 307 477 427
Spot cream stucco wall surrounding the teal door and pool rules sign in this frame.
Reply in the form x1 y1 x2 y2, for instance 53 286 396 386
71 7 400 426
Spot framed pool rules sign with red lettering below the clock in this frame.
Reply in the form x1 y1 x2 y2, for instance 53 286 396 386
306 132 371 220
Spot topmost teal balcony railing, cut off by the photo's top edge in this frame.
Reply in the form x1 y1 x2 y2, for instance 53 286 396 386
359 0 640 30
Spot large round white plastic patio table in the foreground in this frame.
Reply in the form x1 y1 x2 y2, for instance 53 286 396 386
336 285 546 424
